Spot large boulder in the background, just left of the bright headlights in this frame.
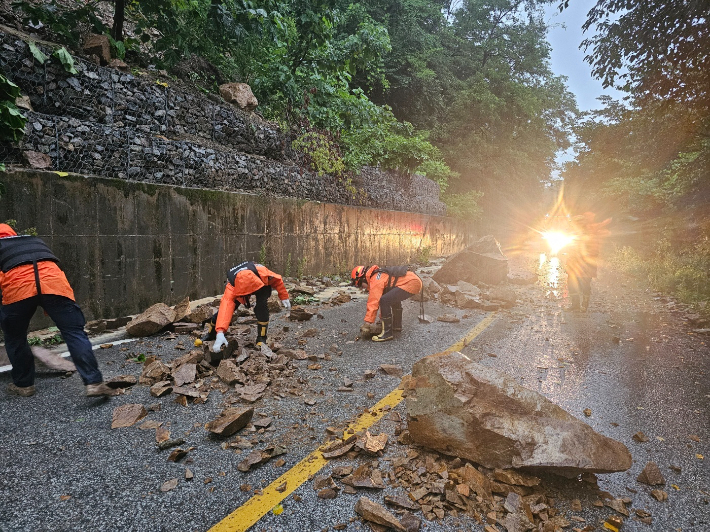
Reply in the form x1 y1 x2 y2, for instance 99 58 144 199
432 235 508 285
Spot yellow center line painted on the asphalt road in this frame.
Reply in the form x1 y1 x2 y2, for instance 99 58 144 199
208 312 497 532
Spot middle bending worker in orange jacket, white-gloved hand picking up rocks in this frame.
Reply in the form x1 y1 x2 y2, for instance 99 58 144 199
207 261 291 353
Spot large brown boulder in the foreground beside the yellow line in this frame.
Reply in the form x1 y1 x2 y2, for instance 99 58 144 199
405 352 631 475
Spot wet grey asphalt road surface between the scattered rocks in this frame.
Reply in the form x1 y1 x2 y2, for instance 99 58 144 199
0 254 710 532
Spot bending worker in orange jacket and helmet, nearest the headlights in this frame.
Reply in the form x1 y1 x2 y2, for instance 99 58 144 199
350 265 422 342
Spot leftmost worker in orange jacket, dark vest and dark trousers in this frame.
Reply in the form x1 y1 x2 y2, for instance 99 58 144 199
0 224 115 397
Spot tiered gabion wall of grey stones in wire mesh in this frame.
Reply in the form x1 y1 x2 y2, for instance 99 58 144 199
0 32 445 215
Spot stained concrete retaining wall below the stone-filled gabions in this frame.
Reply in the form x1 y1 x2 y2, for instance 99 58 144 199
0 171 473 319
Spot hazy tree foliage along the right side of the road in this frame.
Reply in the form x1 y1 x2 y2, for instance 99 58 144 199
565 0 710 310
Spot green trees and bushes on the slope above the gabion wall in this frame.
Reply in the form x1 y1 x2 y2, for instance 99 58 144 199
9 0 575 220
